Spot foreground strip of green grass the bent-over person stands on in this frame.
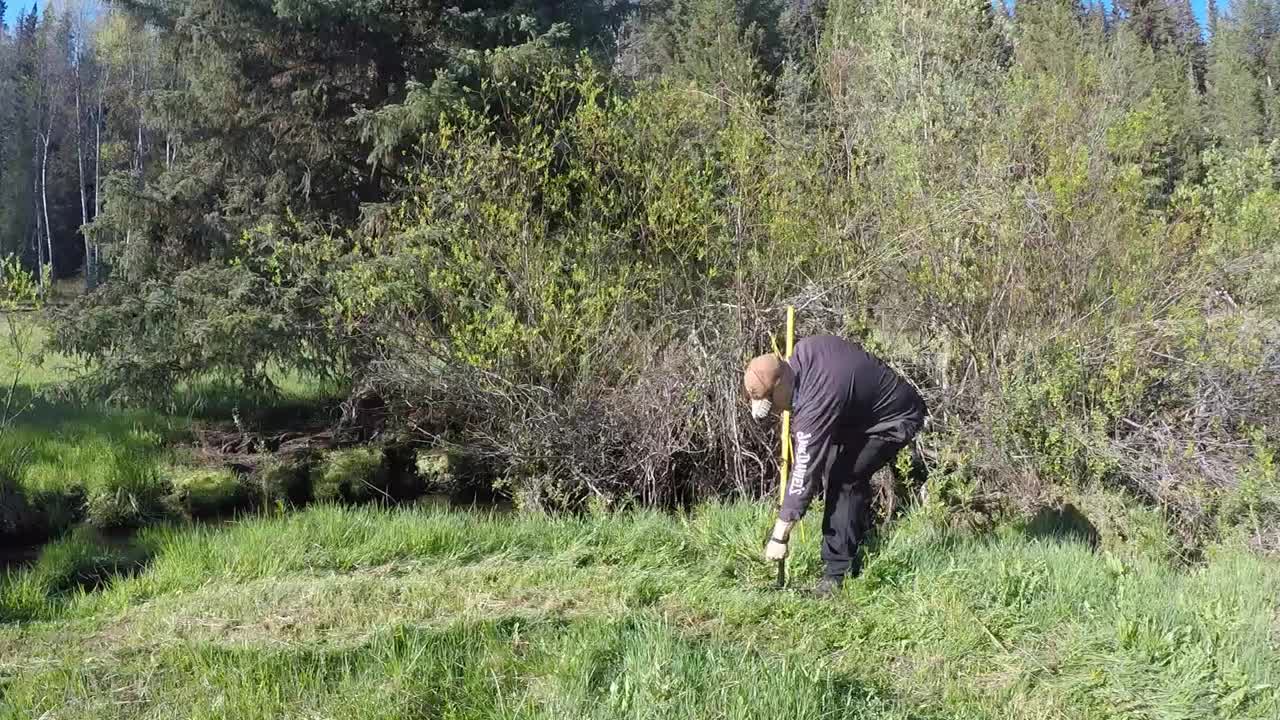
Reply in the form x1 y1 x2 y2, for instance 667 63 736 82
0 497 1280 720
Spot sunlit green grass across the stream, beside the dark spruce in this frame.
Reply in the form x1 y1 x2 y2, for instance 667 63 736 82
0 314 340 539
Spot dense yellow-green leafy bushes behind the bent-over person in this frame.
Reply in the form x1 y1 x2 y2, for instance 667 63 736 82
45 0 1280 537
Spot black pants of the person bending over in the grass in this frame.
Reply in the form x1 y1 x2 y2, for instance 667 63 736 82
822 436 906 577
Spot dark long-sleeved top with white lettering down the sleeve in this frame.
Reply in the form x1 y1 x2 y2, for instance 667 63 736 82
780 336 925 521
